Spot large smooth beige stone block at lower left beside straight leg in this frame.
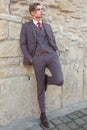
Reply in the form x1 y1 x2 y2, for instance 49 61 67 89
0 76 38 125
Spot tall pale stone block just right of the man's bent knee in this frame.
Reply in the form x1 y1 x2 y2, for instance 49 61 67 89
63 63 83 106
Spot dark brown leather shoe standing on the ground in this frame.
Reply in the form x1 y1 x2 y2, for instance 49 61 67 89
40 114 50 130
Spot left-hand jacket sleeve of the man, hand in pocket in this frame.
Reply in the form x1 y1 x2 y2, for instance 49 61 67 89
20 23 32 61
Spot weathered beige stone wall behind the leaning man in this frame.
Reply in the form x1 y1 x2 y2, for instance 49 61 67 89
0 0 87 125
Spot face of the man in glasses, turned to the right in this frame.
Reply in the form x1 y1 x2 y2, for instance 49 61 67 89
31 5 43 19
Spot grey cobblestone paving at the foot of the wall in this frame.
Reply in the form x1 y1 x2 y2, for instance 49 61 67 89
25 108 87 130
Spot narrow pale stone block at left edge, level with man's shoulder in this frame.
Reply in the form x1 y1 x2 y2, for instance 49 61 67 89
0 20 8 40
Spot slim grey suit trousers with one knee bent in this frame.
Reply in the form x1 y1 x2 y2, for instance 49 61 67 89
33 51 64 113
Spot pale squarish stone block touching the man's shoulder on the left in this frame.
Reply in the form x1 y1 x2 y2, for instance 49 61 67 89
9 22 21 39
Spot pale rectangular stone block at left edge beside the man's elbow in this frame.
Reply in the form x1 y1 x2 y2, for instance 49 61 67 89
0 40 22 57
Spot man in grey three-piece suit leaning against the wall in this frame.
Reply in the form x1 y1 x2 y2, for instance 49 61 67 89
20 2 64 130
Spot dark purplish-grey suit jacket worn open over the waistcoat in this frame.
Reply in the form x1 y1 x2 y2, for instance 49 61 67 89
20 21 58 65
